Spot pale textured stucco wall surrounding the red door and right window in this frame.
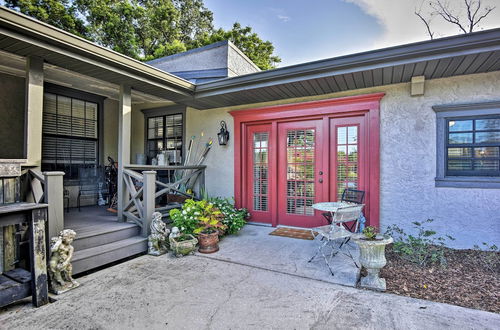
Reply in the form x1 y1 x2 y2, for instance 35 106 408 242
187 72 500 248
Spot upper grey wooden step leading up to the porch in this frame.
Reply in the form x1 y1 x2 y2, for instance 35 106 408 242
73 222 141 251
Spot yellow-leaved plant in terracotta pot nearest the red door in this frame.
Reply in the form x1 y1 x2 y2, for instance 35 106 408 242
194 204 226 253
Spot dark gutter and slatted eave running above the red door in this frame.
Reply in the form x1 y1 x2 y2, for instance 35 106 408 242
184 29 500 109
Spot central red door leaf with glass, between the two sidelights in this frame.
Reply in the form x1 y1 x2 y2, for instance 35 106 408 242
276 119 326 227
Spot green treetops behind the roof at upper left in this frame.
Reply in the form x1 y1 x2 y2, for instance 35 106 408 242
5 0 281 70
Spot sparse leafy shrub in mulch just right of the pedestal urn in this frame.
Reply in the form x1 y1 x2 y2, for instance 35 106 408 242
385 219 454 267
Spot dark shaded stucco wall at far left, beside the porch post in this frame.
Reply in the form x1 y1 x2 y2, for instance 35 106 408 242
0 73 25 159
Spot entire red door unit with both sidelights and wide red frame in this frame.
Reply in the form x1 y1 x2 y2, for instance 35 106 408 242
231 93 383 227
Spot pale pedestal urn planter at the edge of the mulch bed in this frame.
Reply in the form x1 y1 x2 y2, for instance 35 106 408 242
354 235 393 291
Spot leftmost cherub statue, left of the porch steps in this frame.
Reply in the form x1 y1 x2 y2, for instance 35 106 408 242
49 229 80 294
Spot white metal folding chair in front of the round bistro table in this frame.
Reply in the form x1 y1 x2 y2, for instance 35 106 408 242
309 204 364 276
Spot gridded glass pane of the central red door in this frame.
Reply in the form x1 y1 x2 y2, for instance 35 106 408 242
286 129 315 215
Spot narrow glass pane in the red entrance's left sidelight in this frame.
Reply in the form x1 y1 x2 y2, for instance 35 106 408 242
253 132 269 211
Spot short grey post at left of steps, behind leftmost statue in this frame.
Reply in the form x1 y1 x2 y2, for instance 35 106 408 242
43 172 64 239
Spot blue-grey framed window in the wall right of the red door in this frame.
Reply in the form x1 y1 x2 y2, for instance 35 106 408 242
433 101 500 188
